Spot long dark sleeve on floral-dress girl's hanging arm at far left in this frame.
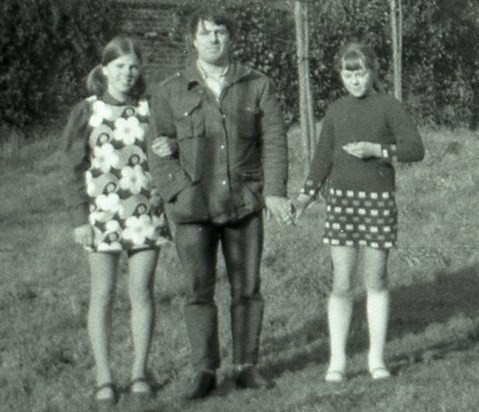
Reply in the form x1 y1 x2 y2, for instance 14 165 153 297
63 101 90 227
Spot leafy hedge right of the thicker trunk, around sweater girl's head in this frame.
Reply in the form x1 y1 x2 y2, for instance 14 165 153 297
310 0 479 126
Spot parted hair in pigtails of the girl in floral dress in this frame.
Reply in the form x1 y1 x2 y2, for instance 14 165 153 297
86 36 146 99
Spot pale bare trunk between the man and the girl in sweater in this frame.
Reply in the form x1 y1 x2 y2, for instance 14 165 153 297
294 0 316 168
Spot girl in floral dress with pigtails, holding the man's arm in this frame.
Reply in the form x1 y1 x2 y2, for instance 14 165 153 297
64 37 168 405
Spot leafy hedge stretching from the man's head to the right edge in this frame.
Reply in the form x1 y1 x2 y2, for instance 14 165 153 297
172 0 479 126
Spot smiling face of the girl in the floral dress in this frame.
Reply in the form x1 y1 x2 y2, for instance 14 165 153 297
103 54 141 100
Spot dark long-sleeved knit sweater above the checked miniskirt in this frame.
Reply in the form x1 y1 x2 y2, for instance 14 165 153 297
304 93 424 195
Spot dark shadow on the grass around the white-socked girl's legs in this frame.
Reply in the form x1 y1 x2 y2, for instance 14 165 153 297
263 262 479 377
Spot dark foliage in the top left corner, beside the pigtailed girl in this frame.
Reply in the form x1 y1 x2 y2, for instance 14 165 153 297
0 0 115 126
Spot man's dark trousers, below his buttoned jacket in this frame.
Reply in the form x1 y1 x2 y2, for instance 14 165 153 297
175 212 264 370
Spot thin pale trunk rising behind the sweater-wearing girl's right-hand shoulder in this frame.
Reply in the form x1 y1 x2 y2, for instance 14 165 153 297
389 0 403 100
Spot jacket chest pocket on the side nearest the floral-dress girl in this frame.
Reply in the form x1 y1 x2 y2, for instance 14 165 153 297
174 99 205 144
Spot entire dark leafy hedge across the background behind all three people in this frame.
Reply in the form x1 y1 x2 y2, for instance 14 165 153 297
0 0 479 130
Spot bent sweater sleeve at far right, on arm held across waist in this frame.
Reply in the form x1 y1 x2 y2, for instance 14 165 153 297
381 98 424 163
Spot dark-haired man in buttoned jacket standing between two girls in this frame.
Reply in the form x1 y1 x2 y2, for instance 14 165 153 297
150 9 293 398
